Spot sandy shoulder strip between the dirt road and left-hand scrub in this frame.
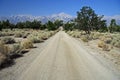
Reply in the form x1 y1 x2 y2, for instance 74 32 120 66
0 37 52 80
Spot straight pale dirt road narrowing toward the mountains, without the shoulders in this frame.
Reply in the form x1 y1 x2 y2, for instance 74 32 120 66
18 31 120 80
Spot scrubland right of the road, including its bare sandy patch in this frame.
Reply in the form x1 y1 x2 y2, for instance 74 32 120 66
67 30 120 69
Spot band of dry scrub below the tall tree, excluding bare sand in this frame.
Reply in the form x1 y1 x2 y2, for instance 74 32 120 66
67 30 120 48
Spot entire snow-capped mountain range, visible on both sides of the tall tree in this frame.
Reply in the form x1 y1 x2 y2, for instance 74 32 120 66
0 12 120 25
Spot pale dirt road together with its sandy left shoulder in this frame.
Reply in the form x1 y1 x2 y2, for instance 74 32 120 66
0 31 120 80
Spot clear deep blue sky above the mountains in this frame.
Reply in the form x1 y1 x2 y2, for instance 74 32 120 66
0 0 120 16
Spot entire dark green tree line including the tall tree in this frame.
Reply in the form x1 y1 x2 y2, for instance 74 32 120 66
0 6 120 34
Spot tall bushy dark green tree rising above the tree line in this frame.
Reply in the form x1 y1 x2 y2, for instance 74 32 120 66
75 6 106 34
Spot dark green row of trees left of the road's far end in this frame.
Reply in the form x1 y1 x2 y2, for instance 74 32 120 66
0 20 63 30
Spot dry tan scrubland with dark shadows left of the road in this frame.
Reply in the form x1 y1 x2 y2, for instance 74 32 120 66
0 29 57 68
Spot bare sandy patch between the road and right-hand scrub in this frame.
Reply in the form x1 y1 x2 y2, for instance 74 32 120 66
87 40 120 71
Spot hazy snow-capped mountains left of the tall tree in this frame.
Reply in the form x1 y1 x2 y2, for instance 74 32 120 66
0 13 74 24
